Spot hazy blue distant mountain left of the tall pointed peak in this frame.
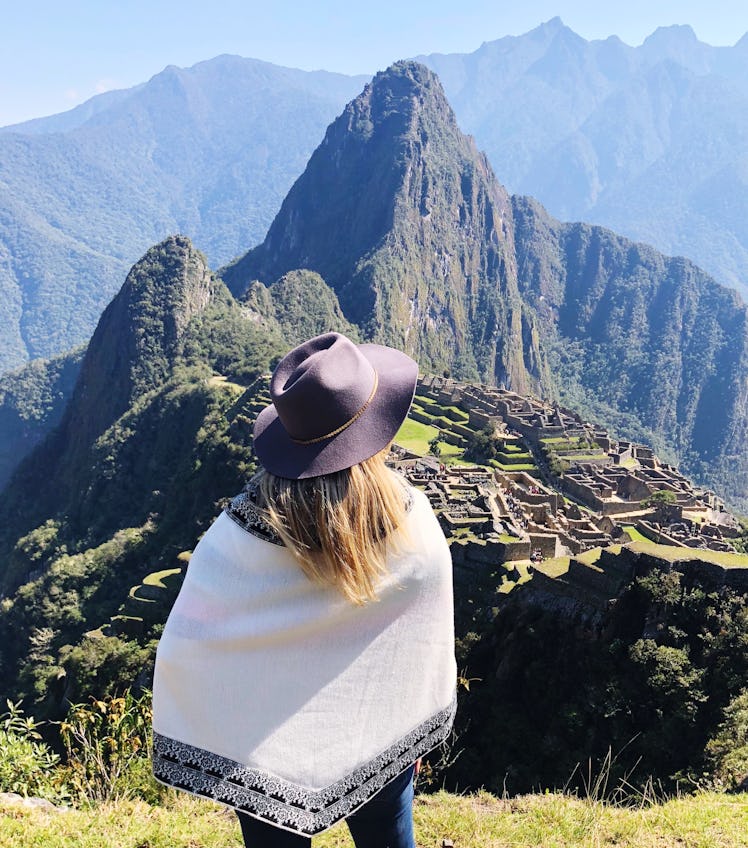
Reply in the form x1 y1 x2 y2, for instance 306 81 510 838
0 56 365 371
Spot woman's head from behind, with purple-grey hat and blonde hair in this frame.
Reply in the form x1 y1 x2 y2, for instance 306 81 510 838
248 333 418 604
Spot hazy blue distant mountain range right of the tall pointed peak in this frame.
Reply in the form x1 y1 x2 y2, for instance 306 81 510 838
418 18 748 297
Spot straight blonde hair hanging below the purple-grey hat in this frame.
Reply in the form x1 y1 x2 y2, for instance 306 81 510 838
255 450 407 605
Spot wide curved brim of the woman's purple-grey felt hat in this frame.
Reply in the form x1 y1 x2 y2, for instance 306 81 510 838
254 344 418 480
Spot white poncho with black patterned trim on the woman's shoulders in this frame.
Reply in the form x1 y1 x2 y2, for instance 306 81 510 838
153 480 456 835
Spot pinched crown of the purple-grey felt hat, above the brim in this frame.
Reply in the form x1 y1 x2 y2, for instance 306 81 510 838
270 333 377 444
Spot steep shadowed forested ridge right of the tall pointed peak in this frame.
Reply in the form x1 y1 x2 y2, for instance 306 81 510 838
513 197 748 509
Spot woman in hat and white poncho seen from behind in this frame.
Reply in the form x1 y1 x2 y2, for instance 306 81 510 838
153 333 456 848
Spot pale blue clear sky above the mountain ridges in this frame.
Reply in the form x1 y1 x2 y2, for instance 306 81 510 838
0 0 748 126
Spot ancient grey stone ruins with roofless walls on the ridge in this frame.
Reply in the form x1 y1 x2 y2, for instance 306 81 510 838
390 376 740 563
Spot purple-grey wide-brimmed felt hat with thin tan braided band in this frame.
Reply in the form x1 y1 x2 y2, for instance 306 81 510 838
254 333 418 480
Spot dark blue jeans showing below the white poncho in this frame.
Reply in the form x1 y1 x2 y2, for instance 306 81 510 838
237 766 416 848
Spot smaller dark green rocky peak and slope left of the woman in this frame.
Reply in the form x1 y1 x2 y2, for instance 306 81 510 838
0 236 290 711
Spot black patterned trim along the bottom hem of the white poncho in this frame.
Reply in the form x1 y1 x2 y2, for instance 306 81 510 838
153 695 457 836
